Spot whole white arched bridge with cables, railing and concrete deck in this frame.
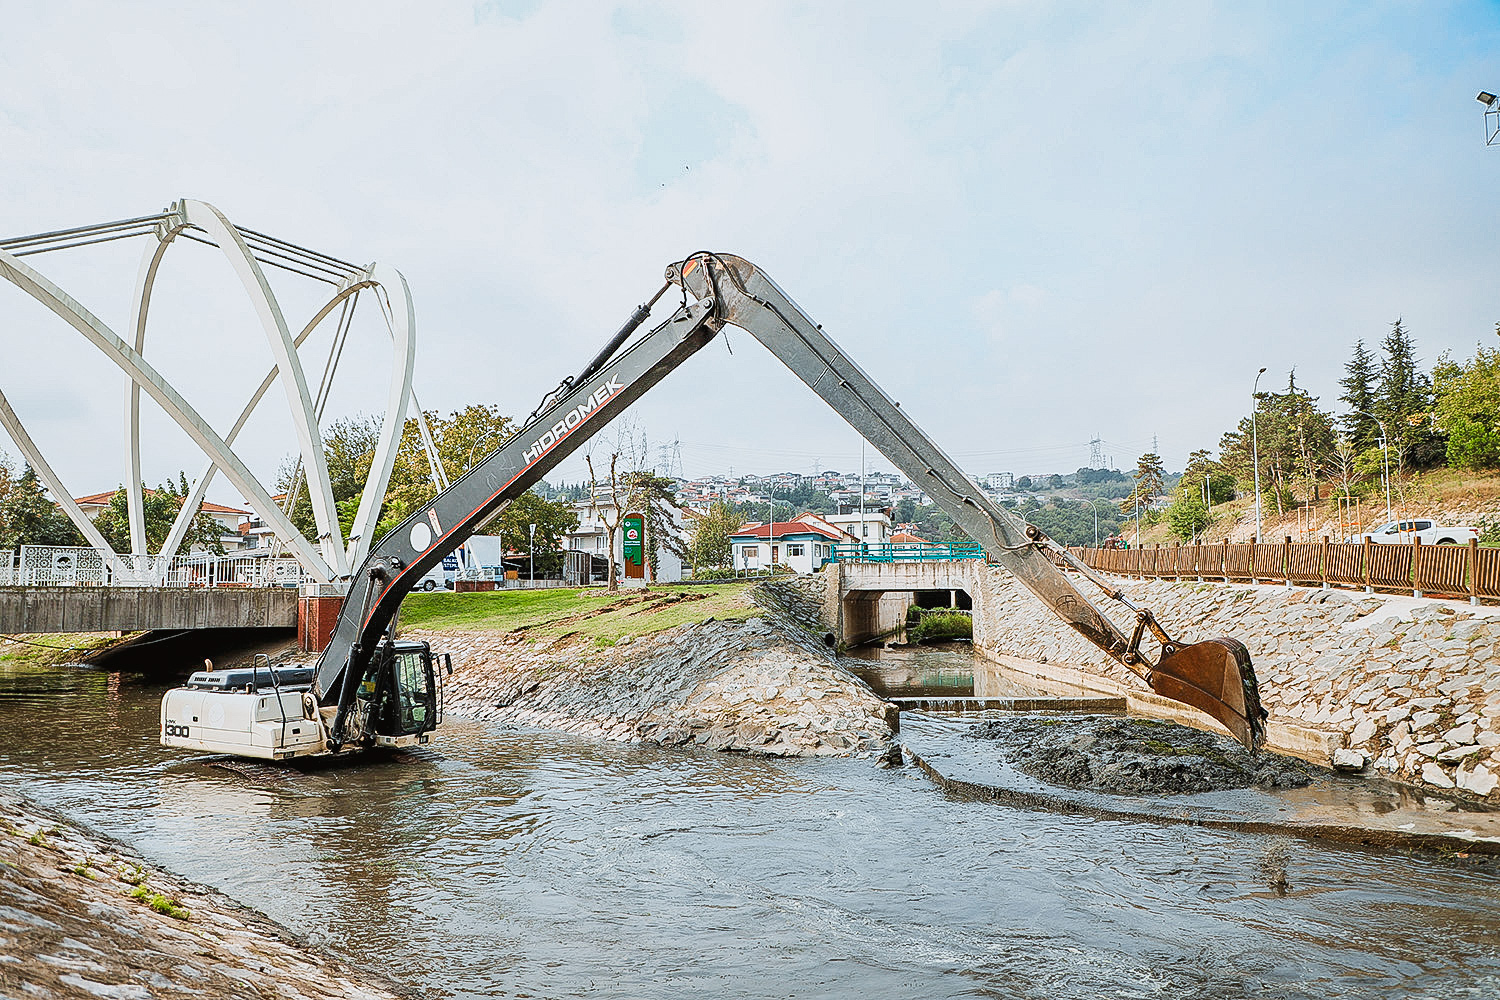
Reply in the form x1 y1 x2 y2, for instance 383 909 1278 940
0 199 447 631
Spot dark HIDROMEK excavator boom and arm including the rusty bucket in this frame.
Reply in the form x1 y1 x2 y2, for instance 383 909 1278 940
314 253 1265 750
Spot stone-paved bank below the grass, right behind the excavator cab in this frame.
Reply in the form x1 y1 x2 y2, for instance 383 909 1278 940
417 583 897 757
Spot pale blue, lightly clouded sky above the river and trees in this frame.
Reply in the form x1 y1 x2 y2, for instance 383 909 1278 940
0 0 1500 504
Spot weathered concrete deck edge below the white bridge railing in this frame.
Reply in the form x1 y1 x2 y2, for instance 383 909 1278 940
0 586 297 633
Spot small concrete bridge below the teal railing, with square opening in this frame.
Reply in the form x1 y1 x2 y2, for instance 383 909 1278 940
824 559 984 645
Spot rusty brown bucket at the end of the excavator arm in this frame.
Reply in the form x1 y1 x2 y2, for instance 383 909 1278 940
1151 639 1266 754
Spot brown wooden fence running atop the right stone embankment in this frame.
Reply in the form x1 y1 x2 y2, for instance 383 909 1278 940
1070 538 1500 604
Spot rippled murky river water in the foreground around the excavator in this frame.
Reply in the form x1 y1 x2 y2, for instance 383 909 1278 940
0 656 1500 1000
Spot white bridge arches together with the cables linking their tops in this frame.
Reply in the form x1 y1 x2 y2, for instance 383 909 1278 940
0 199 444 583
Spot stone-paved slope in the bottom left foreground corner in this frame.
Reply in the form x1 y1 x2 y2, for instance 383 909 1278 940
0 792 407 1000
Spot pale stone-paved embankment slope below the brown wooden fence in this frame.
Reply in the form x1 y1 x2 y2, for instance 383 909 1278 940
975 567 1500 802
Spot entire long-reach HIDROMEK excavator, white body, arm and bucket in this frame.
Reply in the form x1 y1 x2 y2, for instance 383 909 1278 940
161 252 1266 760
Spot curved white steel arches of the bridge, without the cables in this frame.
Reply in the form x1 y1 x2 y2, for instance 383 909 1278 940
0 201 438 583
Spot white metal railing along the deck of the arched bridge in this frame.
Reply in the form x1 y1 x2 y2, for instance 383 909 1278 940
0 546 305 588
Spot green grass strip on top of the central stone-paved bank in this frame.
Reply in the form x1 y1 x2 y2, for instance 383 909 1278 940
401 583 764 646
